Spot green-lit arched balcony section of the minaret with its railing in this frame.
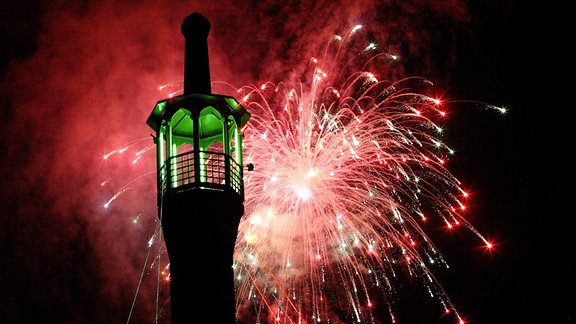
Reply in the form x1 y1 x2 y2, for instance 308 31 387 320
147 93 250 200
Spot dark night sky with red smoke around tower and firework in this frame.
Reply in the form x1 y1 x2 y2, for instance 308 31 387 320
0 0 576 323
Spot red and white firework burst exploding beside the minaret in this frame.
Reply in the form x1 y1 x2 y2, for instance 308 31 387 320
228 26 503 323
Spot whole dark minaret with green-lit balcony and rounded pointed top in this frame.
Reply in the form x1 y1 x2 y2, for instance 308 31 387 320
146 12 250 324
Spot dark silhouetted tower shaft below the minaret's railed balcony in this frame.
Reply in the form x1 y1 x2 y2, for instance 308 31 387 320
161 189 244 324
